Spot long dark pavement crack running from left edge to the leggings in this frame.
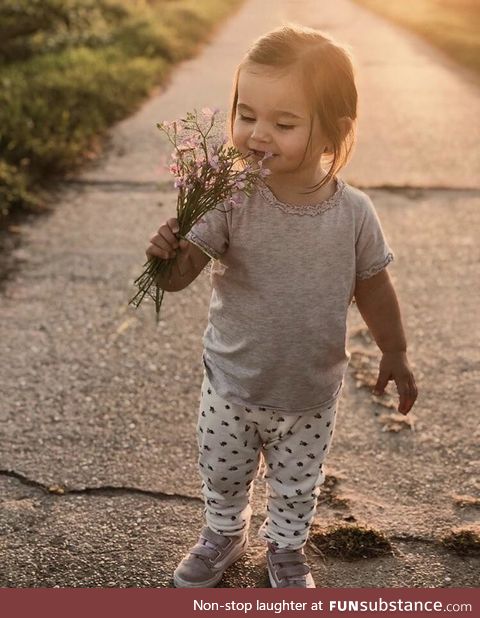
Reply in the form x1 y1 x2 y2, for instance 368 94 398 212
0 470 203 504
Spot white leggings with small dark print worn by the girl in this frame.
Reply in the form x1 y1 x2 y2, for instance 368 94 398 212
197 373 338 549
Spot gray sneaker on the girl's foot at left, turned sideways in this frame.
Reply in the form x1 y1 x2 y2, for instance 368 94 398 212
173 526 248 588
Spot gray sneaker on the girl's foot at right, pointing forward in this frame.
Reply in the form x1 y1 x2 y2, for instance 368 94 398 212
267 543 316 588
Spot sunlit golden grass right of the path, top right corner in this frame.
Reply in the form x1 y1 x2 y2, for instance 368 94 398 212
355 0 480 74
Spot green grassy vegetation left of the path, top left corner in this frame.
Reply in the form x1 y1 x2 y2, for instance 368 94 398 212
0 0 241 221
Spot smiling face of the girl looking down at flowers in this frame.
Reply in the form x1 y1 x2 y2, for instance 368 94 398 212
233 64 327 180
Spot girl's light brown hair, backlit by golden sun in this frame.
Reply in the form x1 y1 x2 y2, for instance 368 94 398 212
230 24 357 191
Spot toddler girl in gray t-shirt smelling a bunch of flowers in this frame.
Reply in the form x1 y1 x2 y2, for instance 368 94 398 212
146 26 417 588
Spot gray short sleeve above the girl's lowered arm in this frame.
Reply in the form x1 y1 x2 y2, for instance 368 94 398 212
355 196 395 279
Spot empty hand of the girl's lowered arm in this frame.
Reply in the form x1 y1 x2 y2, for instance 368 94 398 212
373 352 418 414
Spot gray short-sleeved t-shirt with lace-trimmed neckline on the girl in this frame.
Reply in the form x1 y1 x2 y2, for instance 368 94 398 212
187 178 394 414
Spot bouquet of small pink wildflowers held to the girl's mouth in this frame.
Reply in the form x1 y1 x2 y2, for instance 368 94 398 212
129 109 270 323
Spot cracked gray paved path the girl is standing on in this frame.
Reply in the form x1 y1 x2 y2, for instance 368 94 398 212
0 0 480 587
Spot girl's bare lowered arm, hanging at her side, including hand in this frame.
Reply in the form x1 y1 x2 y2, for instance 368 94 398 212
355 269 418 414
